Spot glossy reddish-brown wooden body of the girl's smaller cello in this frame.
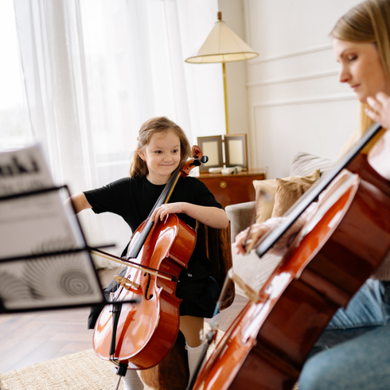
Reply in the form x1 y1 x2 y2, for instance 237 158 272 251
93 214 196 369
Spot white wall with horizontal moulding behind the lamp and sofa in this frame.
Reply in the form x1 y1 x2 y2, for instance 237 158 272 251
219 0 360 178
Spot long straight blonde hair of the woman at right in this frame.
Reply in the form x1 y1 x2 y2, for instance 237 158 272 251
330 0 390 136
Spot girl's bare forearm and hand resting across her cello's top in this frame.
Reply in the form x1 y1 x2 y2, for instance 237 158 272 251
151 202 229 229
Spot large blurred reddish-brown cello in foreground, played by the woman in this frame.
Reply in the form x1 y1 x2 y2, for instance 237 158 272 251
189 124 390 390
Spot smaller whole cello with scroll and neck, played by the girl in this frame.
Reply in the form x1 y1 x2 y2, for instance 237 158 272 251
93 146 207 375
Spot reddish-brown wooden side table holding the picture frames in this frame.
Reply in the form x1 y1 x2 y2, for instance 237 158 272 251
195 169 266 207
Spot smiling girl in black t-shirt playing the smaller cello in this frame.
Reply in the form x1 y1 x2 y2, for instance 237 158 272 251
72 117 229 390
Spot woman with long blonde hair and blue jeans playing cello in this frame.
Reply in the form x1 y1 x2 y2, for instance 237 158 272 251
236 0 390 390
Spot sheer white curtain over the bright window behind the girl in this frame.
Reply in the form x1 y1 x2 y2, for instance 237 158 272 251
14 0 225 266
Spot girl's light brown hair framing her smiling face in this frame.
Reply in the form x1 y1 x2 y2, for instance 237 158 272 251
130 116 191 177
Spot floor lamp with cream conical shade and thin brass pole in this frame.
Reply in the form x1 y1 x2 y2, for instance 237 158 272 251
185 12 259 134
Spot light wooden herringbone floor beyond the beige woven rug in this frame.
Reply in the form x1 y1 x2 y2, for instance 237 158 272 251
0 270 247 373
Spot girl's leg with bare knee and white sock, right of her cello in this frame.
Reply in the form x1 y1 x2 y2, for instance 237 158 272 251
180 316 204 378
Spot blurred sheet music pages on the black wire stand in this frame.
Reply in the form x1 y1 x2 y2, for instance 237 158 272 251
0 146 102 310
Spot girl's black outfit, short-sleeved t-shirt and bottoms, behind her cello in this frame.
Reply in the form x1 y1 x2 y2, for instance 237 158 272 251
84 176 223 317
